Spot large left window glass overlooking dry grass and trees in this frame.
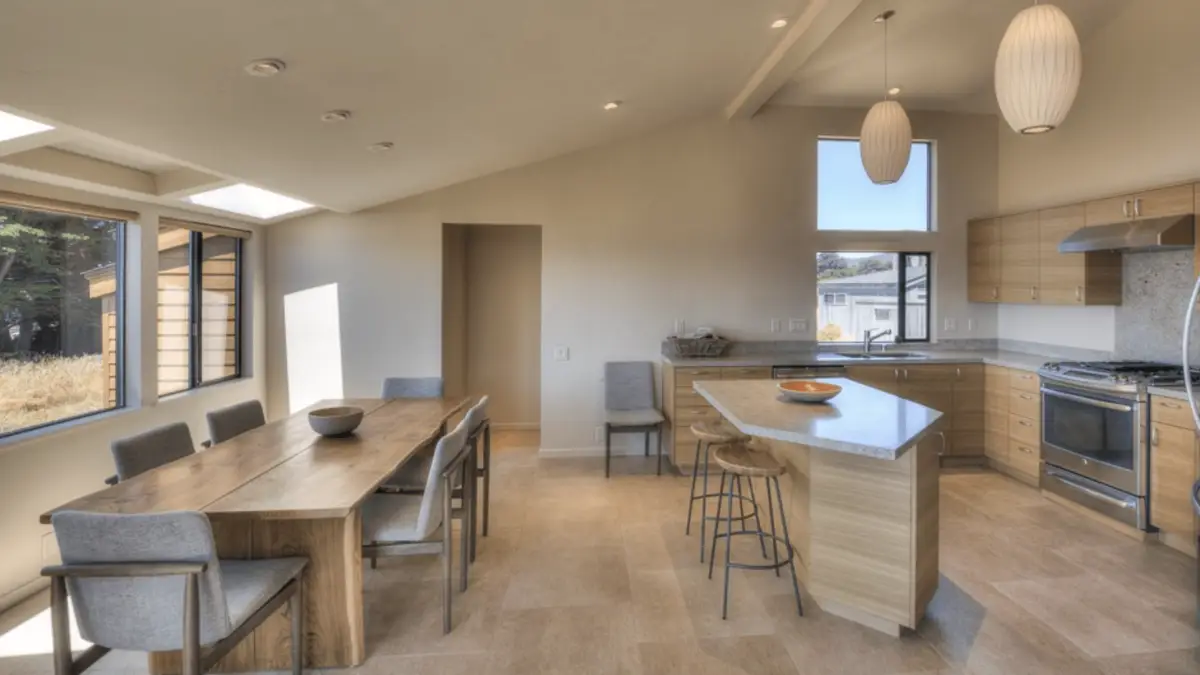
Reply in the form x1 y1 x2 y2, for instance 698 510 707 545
0 207 125 435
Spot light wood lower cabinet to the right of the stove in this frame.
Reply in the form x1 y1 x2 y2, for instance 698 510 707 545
1150 396 1200 556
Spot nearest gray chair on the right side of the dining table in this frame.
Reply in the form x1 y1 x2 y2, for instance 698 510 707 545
362 418 474 633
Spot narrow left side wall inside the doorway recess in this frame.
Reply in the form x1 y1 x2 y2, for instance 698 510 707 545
442 223 468 396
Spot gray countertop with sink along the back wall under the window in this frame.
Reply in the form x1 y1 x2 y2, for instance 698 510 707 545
662 350 1062 371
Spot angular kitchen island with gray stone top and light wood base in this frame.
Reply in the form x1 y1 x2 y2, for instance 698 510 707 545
692 378 943 635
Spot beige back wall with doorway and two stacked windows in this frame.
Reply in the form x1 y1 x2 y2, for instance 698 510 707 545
268 106 998 449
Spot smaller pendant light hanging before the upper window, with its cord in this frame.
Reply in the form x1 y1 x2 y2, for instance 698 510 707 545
858 10 912 185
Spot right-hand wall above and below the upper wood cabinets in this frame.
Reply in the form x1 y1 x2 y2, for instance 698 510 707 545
998 0 1200 350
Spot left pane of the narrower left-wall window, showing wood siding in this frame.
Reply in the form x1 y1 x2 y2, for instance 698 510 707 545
158 227 192 396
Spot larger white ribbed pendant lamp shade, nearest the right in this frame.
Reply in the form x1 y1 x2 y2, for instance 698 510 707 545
996 5 1084 133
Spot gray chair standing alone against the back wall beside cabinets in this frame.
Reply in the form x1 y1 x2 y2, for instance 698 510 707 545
604 362 666 478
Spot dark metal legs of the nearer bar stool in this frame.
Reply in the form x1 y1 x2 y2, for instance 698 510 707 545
708 471 804 620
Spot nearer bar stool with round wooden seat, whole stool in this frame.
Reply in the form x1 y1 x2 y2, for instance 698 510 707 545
708 443 804 620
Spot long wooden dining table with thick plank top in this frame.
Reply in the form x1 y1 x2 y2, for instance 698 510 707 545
42 398 469 675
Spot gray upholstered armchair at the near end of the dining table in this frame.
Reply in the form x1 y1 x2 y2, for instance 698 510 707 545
42 510 308 675
